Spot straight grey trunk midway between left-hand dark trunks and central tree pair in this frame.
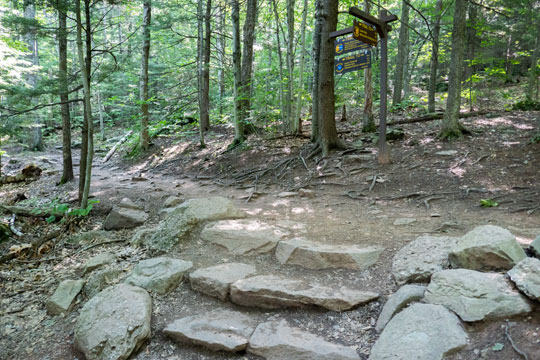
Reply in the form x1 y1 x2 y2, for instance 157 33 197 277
139 0 152 150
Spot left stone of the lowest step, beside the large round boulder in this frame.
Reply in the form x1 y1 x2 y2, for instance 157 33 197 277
163 310 256 352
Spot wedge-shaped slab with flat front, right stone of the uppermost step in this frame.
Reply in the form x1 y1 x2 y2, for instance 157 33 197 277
276 238 384 270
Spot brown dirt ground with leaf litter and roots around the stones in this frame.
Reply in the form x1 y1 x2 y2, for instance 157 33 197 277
0 107 540 360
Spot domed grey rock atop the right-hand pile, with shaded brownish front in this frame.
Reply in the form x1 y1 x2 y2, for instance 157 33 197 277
449 225 526 270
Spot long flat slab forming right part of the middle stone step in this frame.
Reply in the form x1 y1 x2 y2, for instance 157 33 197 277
231 275 379 311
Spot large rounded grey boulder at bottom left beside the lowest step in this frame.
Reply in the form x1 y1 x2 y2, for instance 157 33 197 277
75 284 152 360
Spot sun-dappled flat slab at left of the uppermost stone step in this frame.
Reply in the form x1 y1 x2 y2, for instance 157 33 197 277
201 219 289 255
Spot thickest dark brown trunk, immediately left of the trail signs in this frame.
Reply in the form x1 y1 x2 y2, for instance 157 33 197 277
319 0 342 156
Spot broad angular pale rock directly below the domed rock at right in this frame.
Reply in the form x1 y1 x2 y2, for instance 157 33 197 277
424 269 532 321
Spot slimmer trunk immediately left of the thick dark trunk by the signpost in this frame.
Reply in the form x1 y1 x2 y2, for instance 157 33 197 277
311 0 324 142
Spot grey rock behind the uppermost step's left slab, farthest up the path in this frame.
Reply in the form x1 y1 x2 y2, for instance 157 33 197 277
175 196 246 221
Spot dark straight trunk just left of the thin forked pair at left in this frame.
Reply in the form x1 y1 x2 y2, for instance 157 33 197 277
56 0 75 184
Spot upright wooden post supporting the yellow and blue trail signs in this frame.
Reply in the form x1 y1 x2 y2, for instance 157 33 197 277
378 10 391 165
